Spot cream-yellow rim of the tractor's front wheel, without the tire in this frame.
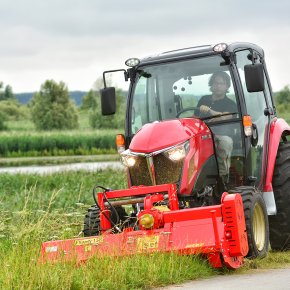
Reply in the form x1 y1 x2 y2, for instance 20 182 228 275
253 204 266 251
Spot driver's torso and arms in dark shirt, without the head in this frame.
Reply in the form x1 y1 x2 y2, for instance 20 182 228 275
197 95 237 118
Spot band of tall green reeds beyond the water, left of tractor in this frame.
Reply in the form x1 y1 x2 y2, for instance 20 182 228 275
0 130 116 157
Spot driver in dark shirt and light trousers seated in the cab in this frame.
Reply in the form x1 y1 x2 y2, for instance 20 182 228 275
197 71 237 184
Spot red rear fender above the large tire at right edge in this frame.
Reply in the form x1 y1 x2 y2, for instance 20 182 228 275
264 118 290 192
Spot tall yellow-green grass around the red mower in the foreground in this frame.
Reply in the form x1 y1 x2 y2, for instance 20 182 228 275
0 170 290 289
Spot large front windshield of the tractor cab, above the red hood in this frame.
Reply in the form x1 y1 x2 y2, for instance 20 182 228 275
131 55 237 134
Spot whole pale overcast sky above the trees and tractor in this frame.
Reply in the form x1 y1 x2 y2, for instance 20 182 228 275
0 0 290 93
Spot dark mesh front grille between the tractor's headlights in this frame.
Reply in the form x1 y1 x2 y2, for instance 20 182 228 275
129 153 183 186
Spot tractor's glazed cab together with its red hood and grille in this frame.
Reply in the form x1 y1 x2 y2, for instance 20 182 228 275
102 43 275 205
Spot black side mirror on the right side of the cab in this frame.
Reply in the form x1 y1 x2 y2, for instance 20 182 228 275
244 63 265 93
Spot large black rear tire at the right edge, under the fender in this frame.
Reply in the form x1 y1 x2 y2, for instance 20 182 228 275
269 142 290 250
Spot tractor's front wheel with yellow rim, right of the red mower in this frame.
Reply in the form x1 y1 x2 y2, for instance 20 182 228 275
231 186 269 259
